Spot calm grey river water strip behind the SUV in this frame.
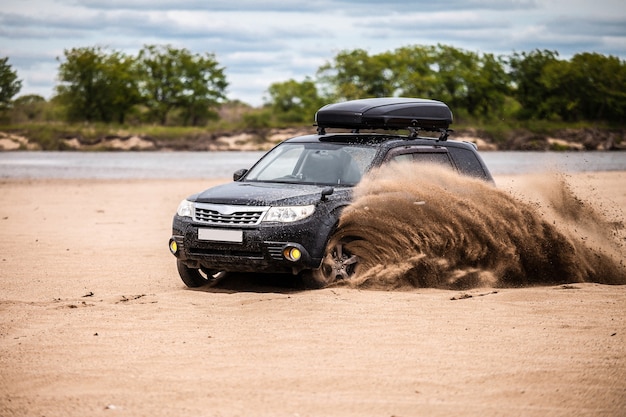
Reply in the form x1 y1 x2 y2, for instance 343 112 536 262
0 151 626 179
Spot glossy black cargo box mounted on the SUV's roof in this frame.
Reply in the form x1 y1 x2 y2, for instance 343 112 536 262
315 97 452 131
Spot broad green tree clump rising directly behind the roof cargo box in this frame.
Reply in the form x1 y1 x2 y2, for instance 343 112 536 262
318 45 509 118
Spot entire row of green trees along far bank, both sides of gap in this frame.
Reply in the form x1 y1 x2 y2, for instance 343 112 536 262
0 45 626 127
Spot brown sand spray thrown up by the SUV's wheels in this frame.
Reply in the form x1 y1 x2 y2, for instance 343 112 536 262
334 163 626 289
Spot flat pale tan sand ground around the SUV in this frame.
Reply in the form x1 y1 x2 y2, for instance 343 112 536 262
0 172 626 417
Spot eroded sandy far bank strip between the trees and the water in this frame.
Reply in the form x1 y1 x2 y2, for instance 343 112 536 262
0 127 626 152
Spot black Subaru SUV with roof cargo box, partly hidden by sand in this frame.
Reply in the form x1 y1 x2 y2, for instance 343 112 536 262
169 98 493 287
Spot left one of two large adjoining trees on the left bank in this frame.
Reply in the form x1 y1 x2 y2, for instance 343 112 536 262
56 47 140 123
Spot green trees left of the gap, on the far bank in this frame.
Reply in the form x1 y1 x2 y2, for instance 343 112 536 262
1 45 228 126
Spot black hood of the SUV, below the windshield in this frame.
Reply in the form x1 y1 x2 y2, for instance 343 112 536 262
189 182 352 206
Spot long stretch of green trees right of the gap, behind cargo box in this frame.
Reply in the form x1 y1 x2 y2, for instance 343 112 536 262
269 45 626 124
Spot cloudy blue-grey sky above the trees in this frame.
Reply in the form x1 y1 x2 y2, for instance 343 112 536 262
0 0 626 106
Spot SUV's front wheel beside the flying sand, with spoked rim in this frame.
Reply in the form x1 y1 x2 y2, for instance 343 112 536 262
303 239 359 288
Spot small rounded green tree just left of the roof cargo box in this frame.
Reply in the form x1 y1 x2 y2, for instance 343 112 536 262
268 77 325 123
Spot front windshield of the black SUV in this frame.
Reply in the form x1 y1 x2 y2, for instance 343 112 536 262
245 143 376 185
